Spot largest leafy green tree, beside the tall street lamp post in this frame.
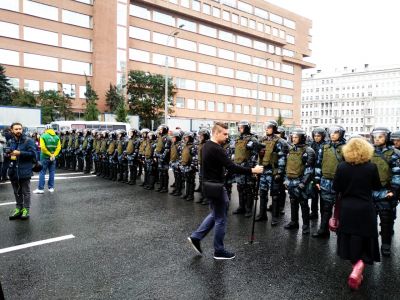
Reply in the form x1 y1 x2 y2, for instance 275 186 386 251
127 70 174 128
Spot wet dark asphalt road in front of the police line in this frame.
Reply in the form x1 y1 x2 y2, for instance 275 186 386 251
0 172 400 299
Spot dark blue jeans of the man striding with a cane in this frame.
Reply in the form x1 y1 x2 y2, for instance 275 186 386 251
191 188 229 252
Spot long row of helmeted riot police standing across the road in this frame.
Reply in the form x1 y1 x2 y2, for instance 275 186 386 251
57 120 400 256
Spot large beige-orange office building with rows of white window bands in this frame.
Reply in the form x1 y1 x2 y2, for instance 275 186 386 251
0 0 314 129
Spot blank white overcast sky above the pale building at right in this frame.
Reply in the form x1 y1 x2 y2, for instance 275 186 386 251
267 0 400 69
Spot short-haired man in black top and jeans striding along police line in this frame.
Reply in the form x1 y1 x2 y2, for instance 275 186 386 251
188 122 263 259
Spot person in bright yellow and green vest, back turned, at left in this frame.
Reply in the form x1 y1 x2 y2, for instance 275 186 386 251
33 125 61 194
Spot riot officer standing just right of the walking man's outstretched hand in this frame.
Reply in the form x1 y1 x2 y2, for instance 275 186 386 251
256 120 288 226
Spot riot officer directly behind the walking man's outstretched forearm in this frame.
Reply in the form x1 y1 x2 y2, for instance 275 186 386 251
233 120 258 218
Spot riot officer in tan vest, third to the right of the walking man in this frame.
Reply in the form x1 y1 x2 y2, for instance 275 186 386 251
285 128 315 234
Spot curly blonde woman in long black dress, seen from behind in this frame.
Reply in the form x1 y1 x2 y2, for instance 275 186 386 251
333 138 381 289
